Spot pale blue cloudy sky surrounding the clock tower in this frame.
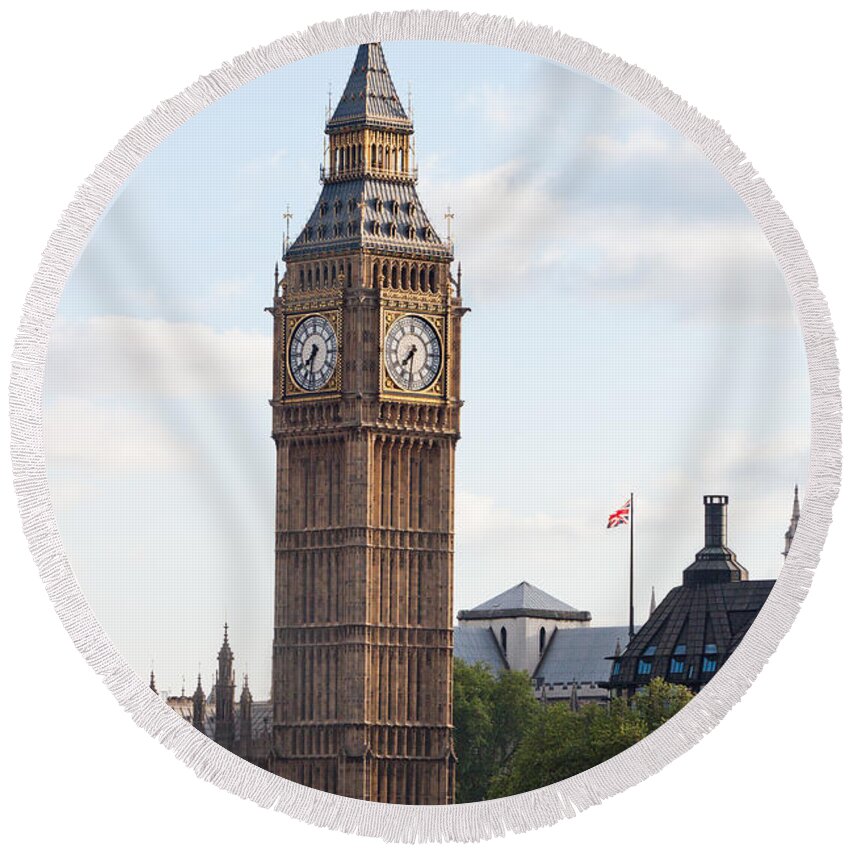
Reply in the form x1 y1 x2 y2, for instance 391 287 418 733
45 42 809 699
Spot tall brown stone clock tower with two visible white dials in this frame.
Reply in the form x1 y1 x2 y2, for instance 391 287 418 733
271 43 464 804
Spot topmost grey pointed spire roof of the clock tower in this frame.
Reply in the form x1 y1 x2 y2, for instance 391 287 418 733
327 41 413 131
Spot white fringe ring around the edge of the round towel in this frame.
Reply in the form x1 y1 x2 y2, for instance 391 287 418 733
11 11 841 842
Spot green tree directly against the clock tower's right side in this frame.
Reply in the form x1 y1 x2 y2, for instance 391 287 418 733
454 659 541 803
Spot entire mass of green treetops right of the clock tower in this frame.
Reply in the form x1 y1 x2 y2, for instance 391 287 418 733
454 660 692 803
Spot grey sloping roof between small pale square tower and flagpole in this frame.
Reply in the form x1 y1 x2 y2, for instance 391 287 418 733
533 626 629 685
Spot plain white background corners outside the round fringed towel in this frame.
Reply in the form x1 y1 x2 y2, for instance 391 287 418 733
0 0 850 848
